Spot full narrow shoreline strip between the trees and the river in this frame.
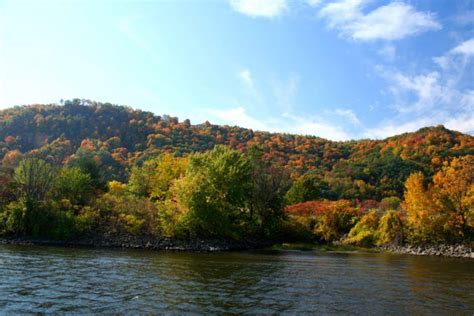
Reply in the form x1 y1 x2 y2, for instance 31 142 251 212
0 236 474 259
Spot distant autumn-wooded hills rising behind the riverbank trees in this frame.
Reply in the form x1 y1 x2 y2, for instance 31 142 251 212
0 99 474 199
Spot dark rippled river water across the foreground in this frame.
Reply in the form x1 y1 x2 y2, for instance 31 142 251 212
0 245 474 315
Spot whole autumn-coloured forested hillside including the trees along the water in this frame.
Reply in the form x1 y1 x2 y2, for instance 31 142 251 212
0 99 474 243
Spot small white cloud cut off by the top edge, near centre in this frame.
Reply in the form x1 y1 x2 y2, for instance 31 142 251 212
230 0 288 18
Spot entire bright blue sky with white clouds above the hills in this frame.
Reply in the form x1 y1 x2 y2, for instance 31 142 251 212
0 0 474 140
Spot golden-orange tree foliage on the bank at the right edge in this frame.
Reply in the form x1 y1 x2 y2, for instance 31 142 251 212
403 155 474 242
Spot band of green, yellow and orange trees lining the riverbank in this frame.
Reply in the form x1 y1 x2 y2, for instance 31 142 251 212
0 146 474 246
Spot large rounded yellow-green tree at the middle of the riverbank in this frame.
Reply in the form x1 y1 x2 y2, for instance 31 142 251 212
175 146 252 239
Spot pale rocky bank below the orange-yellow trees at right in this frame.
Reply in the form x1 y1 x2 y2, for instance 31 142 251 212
380 244 474 259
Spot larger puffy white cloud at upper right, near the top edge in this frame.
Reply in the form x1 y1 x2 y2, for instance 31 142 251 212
319 0 441 41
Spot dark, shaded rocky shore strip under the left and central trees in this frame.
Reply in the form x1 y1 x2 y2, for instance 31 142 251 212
0 235 265 252
